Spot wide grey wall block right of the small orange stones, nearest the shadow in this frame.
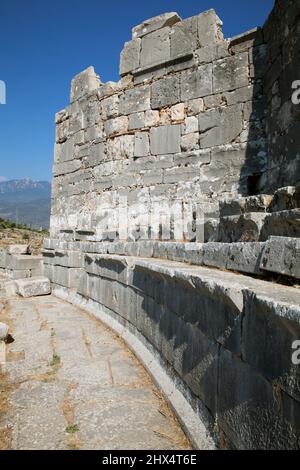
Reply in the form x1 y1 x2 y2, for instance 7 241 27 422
199 105 243 148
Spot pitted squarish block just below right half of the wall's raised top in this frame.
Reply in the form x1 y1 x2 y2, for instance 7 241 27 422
181 64 212 101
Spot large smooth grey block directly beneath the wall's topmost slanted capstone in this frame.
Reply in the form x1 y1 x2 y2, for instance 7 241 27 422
141 27 171 69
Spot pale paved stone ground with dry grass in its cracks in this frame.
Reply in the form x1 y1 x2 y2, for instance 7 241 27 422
0 296 190 450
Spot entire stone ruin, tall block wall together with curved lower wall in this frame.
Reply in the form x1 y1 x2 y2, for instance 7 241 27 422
2 0 300 449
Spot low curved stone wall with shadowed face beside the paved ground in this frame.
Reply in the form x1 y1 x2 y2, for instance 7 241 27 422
54 254 300 449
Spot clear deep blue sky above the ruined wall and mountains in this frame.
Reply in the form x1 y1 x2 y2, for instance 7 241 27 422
0 0 274 181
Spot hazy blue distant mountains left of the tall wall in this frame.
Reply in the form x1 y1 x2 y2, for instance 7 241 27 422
0 178 51 228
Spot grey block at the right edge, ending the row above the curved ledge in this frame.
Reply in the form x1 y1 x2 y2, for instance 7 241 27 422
260 236 300 279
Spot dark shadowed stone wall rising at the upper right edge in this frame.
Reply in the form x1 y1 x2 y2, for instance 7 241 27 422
263 0 300 191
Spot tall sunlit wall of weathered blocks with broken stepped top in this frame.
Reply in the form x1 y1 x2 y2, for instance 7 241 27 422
51 10 266 241
